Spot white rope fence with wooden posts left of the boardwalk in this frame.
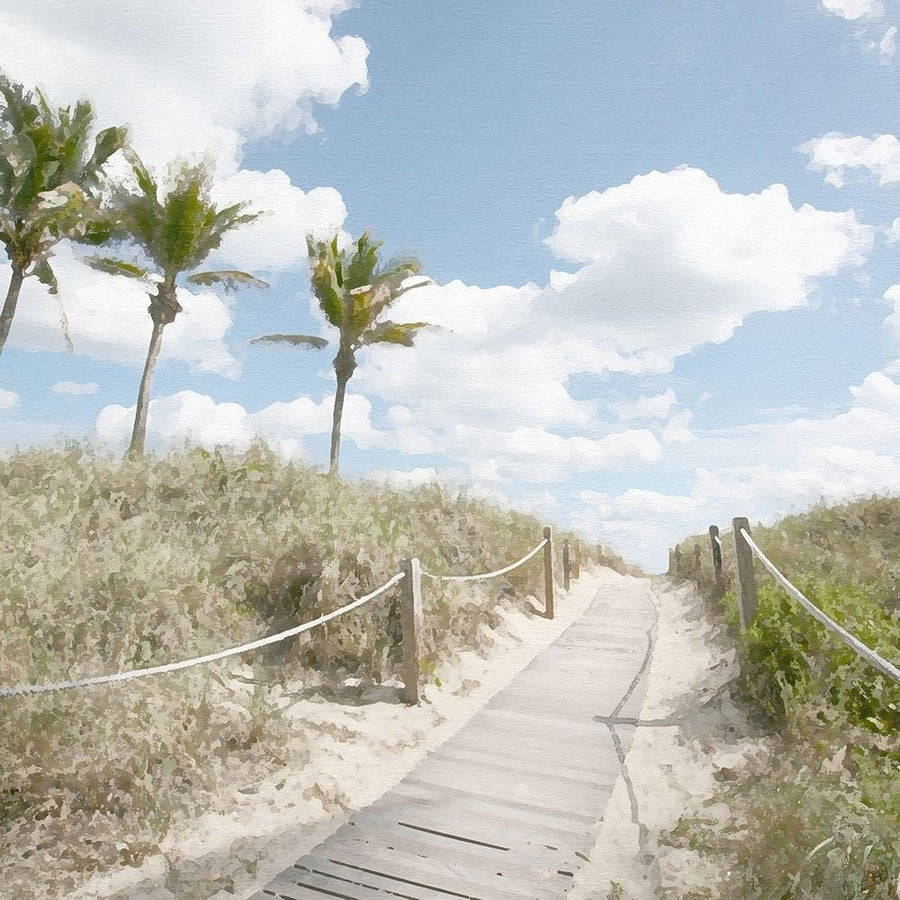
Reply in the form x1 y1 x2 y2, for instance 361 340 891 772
0 528 577 704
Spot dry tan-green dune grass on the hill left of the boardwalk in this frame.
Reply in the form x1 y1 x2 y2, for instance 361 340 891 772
0 444 604 884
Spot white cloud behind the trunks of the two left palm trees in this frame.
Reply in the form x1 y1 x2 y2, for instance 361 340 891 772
9 247 240 378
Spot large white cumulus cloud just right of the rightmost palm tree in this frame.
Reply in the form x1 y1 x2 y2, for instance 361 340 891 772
344 168 873 483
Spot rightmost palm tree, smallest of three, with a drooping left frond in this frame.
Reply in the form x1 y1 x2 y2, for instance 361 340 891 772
252 231 431 475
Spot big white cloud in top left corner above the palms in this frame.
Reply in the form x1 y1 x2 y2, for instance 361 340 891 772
0 0 368 170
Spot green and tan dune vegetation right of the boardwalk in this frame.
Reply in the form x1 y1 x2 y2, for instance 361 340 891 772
680 497 900 900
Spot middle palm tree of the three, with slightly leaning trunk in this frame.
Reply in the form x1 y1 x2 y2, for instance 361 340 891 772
86 151 268 456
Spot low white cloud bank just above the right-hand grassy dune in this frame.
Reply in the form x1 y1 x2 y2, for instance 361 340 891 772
575 372 900 571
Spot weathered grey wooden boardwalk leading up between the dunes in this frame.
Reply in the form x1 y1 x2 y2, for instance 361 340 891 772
251 581 656 900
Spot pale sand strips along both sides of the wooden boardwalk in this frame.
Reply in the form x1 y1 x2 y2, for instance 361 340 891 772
71 569 744 900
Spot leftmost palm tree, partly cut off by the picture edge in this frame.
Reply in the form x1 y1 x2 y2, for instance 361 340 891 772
0 75 125 353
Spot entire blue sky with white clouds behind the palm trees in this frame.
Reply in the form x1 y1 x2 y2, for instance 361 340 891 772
0 0 900 570
